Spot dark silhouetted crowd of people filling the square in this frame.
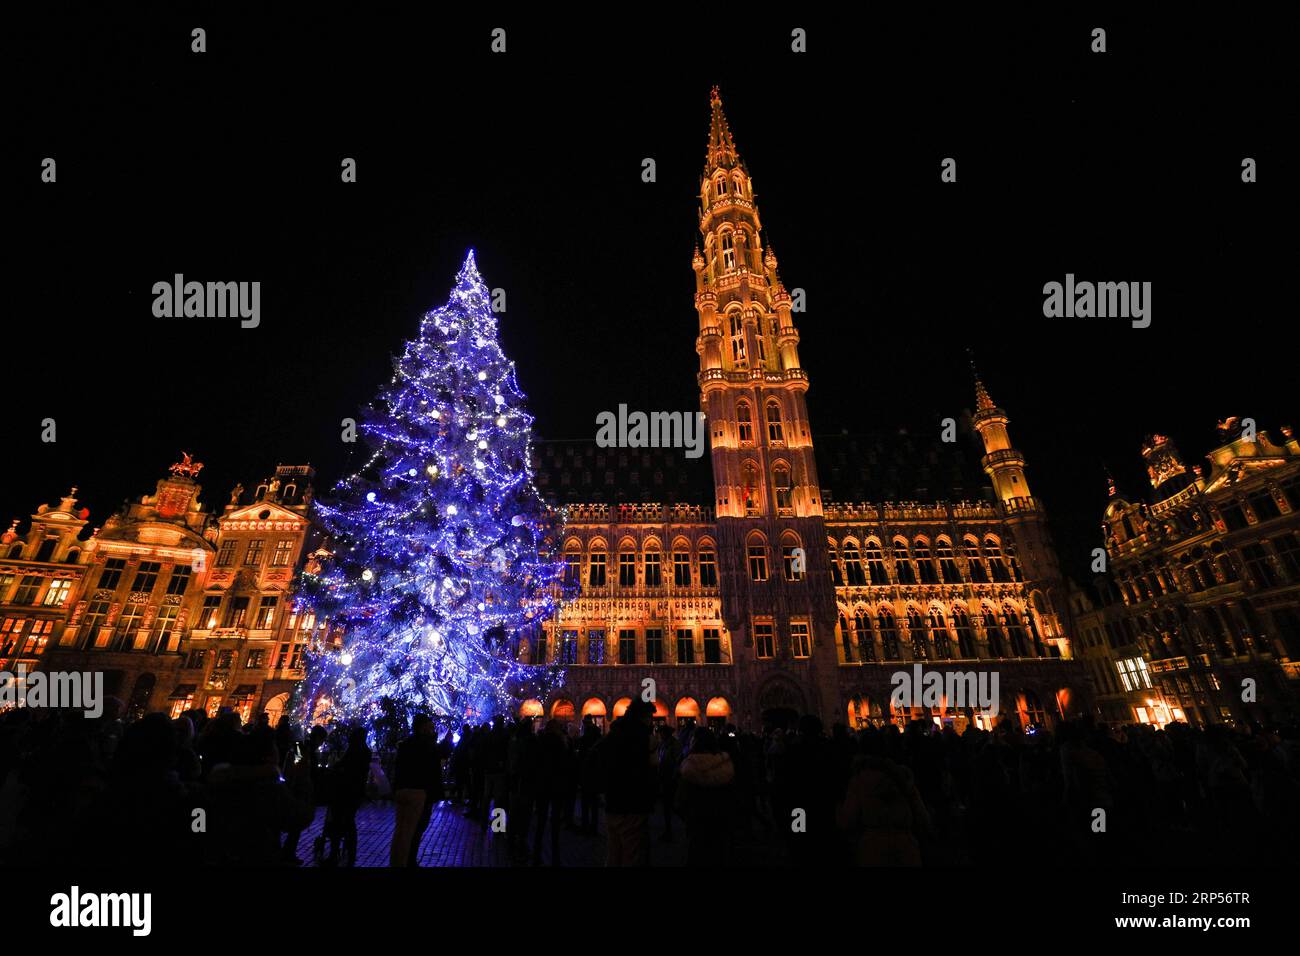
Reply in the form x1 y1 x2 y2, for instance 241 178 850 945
0 701 1300 866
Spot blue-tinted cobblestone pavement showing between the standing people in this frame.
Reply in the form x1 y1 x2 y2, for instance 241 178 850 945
298 800 777 866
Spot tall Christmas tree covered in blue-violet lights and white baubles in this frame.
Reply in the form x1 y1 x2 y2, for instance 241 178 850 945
302 251 564 727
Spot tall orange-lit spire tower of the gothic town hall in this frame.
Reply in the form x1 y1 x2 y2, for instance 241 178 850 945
692 87 836 715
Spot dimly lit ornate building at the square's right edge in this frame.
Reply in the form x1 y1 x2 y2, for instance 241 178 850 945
1082 419 1300 724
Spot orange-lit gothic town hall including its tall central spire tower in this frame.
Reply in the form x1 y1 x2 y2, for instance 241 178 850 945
523 90 1087 728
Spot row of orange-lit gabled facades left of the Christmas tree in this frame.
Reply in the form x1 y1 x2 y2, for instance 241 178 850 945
15 457 335 723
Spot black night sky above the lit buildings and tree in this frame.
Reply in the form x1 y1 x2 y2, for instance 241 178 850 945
10 13 1300 582
